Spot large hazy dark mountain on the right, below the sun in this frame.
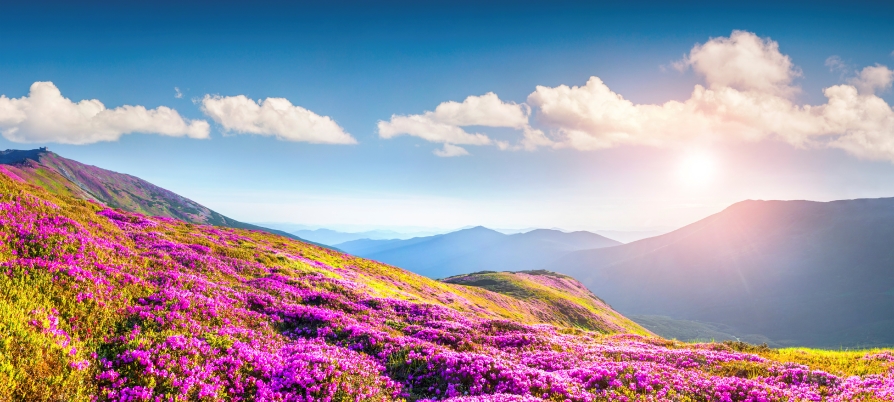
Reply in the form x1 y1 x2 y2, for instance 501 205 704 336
543 198 894 347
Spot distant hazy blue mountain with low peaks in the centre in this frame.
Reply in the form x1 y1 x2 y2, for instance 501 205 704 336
336 226 621 278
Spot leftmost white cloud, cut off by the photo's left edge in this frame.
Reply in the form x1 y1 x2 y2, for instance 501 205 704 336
0 82 209 144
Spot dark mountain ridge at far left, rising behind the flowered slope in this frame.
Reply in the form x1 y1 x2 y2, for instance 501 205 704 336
0 148 316 245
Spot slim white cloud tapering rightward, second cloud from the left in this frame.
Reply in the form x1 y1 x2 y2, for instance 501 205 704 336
201 95 357 144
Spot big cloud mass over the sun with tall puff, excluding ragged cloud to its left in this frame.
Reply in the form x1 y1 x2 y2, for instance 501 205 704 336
527 31 894 161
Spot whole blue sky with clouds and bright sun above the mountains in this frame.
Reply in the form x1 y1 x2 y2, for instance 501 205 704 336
0 1 894 231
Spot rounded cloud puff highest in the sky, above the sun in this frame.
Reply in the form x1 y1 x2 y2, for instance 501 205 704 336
674 31 801 95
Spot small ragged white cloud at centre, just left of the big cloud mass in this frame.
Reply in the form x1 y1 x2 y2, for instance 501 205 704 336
378 92 529 152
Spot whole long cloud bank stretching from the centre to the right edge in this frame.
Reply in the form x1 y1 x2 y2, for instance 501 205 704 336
378 31 894 161
